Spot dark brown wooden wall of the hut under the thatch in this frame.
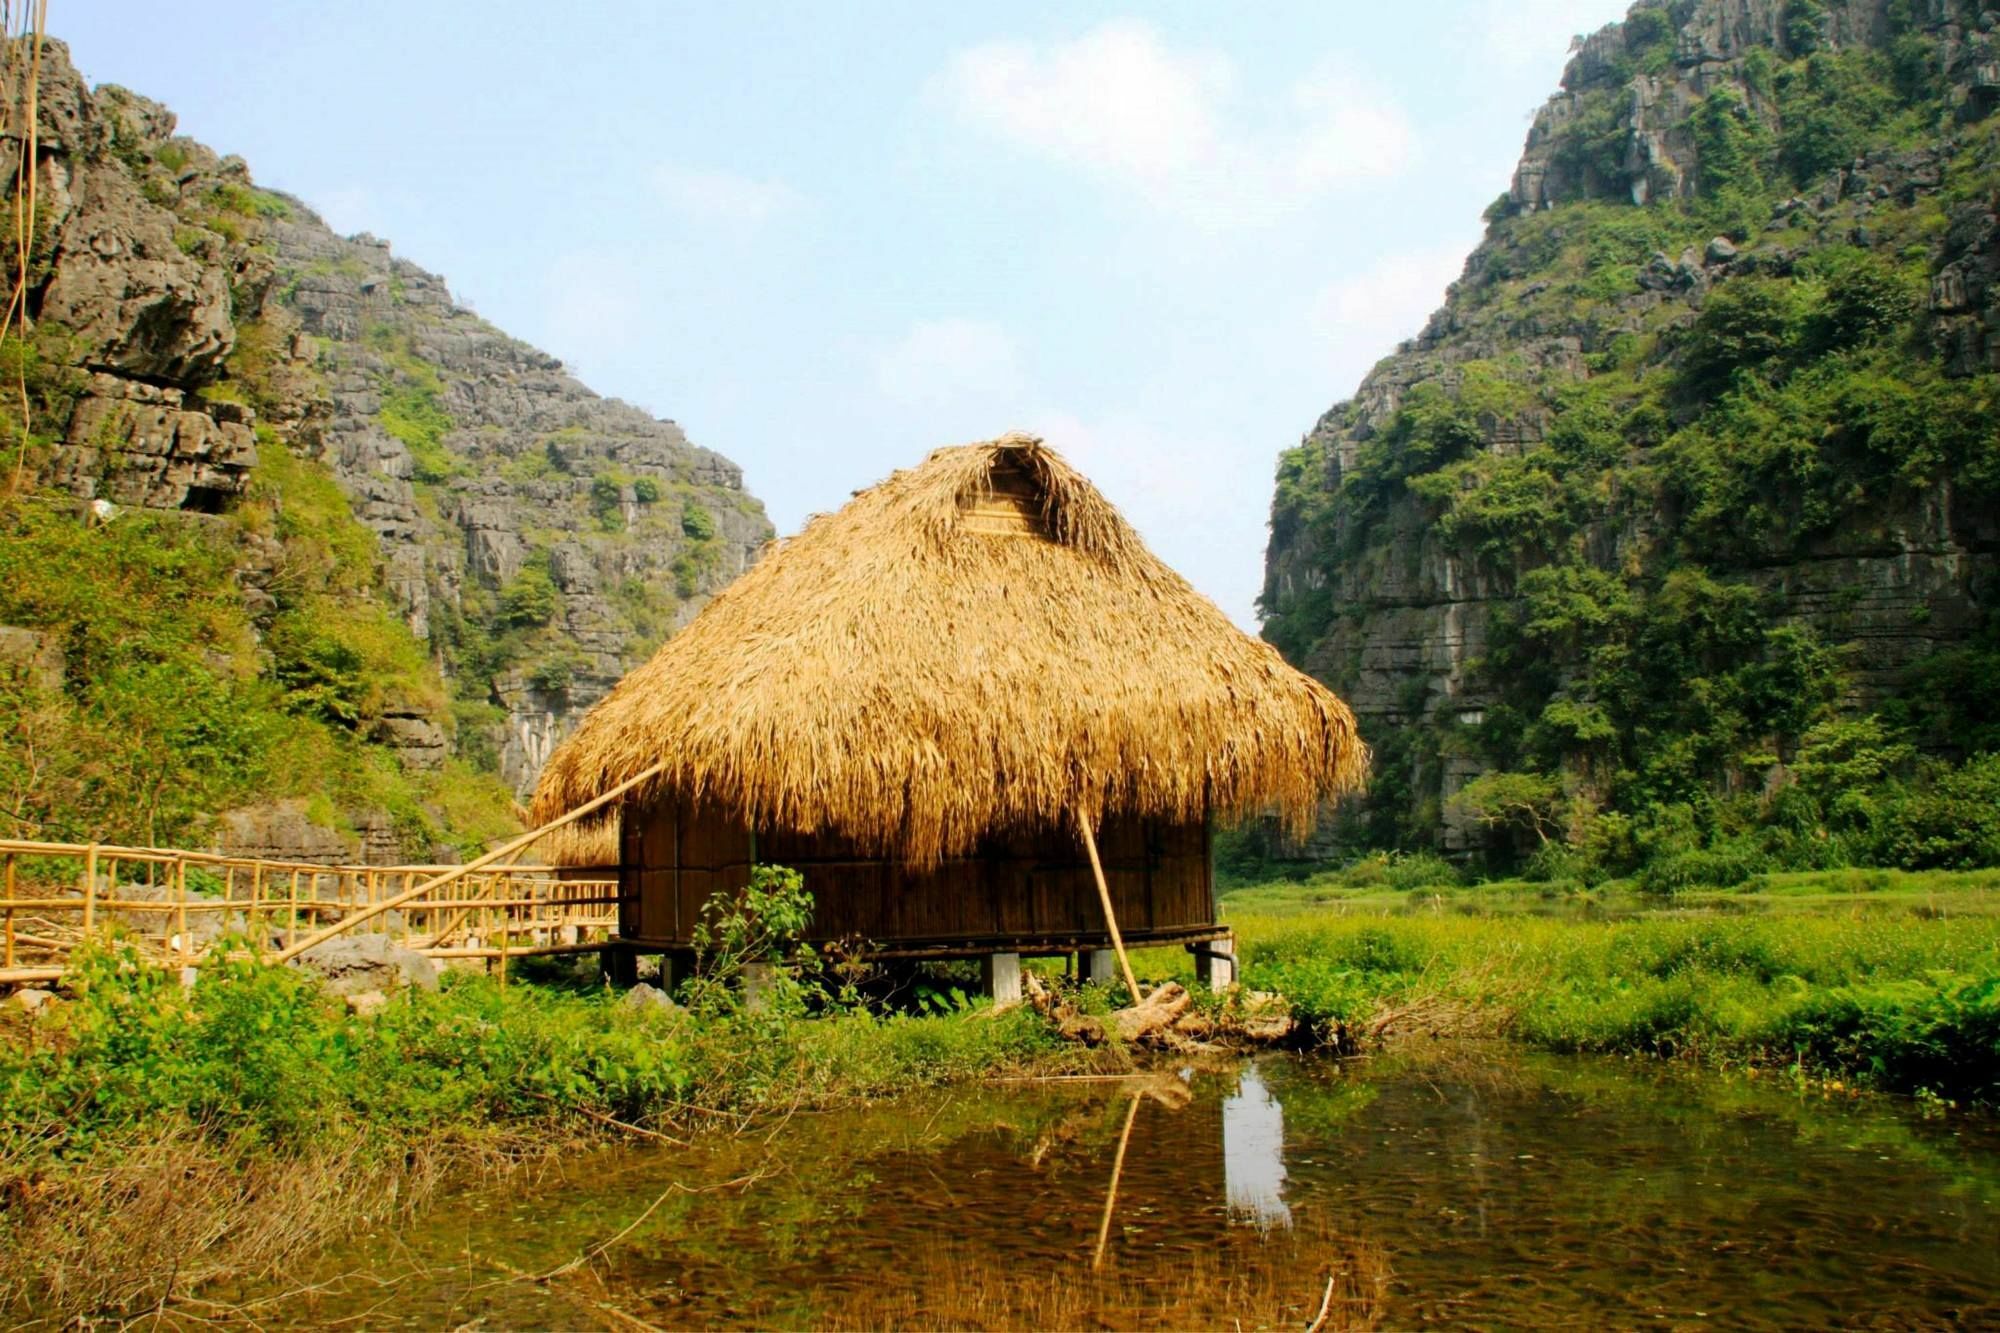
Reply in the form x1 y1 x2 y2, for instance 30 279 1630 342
620 801 1214 951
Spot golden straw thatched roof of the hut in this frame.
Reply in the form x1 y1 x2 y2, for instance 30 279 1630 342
534 434 1368 863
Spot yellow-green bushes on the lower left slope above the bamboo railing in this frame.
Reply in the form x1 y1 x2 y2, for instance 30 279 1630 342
0 418 516 859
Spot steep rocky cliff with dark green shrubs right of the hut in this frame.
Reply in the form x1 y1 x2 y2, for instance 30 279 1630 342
1262 0 2000 849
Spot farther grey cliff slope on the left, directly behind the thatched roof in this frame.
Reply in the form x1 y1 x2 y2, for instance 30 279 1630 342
260 211 772 793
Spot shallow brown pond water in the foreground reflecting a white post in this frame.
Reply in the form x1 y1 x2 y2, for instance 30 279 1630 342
232 1047 2000 1329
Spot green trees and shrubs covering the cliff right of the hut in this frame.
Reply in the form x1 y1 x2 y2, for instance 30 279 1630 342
1264 4 2000 889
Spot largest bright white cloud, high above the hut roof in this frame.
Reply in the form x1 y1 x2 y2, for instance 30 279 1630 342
928 18 1414 226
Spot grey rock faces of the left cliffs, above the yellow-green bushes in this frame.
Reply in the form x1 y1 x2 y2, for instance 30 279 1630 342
6 42 770 851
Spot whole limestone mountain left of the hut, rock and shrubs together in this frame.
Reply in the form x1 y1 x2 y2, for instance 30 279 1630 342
0 42 770 859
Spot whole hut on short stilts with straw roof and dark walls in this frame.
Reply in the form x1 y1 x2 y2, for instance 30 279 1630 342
534 434 1366 993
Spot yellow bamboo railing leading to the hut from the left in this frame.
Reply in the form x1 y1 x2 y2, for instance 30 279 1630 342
0 839 618 985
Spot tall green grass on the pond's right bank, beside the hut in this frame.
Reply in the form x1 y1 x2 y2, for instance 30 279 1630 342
1238 915 2000 1101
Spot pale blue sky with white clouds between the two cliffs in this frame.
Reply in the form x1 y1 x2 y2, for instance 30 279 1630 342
62 0 1624 626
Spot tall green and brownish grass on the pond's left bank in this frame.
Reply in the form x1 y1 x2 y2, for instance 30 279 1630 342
0 951 1074 1323
